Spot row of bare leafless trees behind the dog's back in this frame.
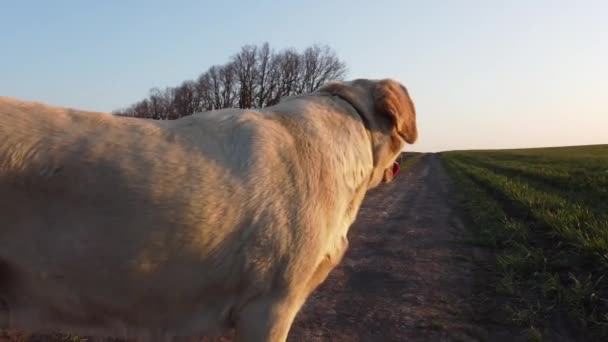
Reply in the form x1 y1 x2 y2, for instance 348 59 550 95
113 43 347 120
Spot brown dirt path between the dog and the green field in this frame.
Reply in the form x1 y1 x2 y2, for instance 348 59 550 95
289 154 513 341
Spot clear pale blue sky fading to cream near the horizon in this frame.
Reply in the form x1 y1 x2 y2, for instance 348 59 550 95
0 0 608 151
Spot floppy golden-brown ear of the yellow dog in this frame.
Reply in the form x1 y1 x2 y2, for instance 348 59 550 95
374 79 418 144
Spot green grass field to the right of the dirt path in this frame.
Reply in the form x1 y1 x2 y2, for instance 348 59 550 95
441 145 608 340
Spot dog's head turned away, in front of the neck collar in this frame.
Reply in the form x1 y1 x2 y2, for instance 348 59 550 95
319 79 418 188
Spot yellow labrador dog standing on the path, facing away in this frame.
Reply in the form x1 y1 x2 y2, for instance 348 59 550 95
0 79 417 341
